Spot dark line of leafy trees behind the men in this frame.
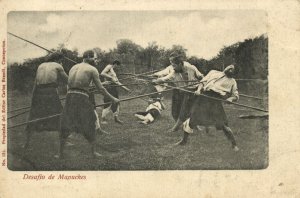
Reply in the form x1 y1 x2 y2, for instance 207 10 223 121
8 35 268 92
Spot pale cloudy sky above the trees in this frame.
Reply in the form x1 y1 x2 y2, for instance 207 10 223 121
7 10 267 63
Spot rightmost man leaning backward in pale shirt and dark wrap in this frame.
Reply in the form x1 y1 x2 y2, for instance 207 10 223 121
177 65 239 151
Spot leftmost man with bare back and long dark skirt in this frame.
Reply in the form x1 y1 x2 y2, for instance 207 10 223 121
23 52 68 149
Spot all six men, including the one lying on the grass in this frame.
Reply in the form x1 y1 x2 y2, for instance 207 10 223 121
25 50 239 158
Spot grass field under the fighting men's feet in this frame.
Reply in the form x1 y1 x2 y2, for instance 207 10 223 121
8 89 268 170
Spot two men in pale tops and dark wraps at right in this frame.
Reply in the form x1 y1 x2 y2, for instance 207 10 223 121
151 53 239 151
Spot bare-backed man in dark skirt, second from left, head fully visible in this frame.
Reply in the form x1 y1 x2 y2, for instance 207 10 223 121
56 50 119 158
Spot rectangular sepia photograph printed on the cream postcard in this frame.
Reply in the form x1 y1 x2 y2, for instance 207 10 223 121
7 9 269 171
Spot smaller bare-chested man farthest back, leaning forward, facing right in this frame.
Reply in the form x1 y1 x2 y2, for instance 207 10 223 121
101 60 130 124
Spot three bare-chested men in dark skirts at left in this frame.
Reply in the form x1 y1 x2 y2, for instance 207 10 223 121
24 50 129 158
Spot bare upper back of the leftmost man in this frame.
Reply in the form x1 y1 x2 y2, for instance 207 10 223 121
36 62 67 85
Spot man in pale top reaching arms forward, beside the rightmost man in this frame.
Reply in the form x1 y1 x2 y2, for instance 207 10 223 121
152 53 203 132
